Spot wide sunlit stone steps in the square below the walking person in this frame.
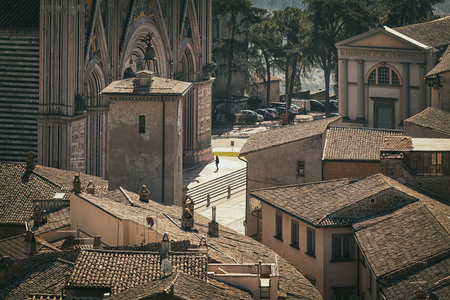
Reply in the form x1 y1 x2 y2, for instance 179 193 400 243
188 168 247 209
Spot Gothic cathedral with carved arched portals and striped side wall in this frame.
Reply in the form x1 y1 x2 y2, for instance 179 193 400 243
0 0 213 178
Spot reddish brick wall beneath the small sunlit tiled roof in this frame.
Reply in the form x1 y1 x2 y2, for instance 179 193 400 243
322 161 381 180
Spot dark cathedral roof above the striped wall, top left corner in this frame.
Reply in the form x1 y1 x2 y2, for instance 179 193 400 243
0 0 40 29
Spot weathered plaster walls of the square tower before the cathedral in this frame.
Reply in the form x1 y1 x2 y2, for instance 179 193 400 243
108 99 182 205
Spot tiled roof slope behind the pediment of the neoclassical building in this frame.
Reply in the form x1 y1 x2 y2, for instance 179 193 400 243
393 16 450 48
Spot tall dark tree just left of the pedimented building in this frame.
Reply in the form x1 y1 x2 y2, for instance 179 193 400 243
304 0 377 117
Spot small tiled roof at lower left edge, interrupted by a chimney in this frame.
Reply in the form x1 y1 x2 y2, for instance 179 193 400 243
0 234 59 260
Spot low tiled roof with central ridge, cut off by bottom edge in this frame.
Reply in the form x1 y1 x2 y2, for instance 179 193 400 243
109 272 253 300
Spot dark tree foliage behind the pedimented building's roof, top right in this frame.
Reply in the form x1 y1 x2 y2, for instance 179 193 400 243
382 0 444 27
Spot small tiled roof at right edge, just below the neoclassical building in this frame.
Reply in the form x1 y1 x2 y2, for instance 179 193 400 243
404 107 450 135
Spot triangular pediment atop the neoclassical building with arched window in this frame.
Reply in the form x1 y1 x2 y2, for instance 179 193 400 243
336 28 426 50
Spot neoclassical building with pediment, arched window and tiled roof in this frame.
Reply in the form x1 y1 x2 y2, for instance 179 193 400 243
336 17 450 129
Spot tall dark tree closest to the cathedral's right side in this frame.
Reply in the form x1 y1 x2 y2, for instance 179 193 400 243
213 0 266 113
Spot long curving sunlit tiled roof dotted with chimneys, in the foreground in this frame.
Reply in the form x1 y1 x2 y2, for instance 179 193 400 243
80 191 322 299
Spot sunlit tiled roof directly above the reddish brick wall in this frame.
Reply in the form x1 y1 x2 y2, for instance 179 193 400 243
322 127 403 161
